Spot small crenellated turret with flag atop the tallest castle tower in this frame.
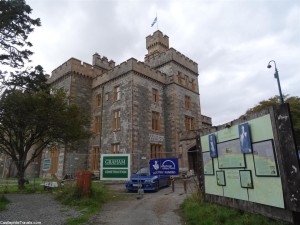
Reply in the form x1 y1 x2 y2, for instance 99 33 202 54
145 30 169 58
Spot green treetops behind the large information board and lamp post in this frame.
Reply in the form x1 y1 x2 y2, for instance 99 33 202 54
246 95 300 149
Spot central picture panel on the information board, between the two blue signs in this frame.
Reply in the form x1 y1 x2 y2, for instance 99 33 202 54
218 139 246 169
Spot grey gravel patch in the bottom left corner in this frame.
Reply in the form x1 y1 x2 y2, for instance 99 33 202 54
0 194 79 225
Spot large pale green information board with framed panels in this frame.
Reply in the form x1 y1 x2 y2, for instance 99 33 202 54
201 114 284 208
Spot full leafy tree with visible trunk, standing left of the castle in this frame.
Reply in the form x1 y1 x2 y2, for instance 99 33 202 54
0 67 89 189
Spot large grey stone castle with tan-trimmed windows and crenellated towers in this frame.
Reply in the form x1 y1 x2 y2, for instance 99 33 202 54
42 30 211 177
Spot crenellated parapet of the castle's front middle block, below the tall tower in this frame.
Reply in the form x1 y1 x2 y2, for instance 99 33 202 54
92 58 166 88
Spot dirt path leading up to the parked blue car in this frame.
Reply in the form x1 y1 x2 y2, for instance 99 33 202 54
89 181 196 225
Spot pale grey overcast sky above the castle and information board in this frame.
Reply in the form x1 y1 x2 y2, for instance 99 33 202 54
27 0 300 125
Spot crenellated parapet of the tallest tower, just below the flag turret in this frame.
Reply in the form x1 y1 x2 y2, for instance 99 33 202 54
145 48 198 74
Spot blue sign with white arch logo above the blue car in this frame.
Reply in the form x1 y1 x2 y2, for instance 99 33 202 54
149 158 179 176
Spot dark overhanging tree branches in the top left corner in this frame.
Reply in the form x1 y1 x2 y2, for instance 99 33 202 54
0 0 41 68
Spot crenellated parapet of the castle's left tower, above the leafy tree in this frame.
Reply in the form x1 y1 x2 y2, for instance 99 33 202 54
48 58 99 83
